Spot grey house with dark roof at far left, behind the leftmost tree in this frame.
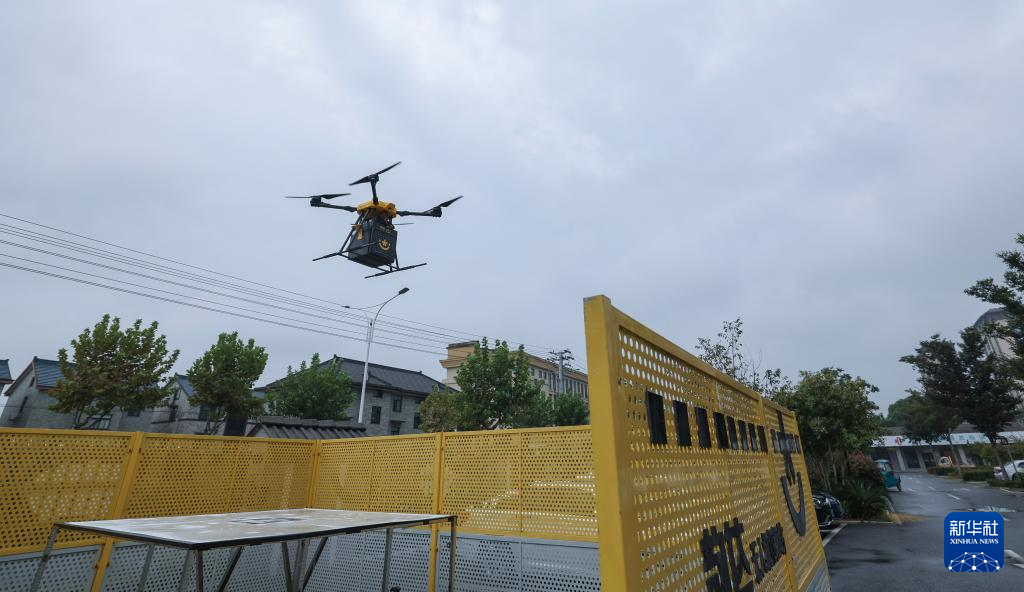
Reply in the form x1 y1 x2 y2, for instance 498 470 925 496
0 357 152 431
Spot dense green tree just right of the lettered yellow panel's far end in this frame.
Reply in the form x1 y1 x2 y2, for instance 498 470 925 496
776 368 882 491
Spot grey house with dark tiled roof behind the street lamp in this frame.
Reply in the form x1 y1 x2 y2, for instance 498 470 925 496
262 356 444 435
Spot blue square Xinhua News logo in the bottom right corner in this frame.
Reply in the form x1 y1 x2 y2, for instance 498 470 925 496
944 512 1004 572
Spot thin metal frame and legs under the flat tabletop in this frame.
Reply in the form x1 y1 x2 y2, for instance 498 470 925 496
29 515 458 592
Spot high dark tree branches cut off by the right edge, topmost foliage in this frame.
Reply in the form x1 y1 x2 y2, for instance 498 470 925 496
966 234 1024 390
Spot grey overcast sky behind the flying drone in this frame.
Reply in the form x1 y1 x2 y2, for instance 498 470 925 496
0 0 1024 409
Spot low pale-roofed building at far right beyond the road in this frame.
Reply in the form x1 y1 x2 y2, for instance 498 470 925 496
871 422 1024 471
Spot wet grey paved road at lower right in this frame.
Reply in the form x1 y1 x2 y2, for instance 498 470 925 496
825 467 1024 592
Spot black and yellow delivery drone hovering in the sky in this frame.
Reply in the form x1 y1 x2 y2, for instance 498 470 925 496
285 162 462 278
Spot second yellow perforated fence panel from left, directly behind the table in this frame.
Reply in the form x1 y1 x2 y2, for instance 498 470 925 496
124 434 314 518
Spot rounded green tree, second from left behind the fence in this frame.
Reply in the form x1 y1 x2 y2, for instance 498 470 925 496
187 332 267 433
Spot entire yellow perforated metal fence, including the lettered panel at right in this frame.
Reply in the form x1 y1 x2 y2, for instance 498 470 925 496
0 297 827 592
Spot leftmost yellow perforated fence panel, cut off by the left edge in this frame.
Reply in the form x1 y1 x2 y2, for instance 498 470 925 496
0 429 131 555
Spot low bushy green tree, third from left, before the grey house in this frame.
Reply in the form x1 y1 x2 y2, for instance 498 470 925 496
266 353 355 421
